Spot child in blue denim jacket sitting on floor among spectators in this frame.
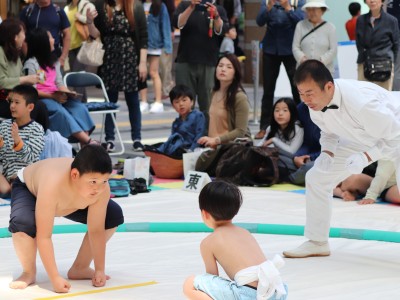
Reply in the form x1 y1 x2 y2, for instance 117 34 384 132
156 85 206 158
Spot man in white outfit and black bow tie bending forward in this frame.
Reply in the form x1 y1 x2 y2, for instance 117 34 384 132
283 60 400 258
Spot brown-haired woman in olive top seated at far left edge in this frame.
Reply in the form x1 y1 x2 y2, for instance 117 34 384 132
0 18 39 118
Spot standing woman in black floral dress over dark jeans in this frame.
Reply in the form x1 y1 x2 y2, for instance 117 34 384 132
87 0 147 151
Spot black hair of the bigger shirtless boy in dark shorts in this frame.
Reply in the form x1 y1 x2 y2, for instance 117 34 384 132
71 144 112 175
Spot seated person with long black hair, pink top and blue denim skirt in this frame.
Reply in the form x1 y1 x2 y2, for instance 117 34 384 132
24 27 99 145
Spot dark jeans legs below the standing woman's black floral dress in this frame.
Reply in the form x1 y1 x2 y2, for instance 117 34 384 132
105 90 142 141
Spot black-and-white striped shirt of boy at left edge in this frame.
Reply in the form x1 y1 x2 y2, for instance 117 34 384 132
0 119 44 181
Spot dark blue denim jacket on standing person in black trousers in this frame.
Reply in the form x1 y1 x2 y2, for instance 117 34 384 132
256 0 305 55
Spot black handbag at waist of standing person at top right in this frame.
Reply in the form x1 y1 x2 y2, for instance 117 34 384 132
364 57 392 82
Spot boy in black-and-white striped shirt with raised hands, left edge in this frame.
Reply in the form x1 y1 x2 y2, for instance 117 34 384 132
0 85 44 194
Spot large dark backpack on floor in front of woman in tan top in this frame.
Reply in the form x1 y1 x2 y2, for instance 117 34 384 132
215 144 279 186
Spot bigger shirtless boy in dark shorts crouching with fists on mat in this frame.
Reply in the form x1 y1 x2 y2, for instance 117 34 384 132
8 144 124 293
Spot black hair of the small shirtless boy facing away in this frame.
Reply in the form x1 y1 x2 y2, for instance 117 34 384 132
199 181 243 221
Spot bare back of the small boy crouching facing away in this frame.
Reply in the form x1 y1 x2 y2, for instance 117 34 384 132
200 223 266 280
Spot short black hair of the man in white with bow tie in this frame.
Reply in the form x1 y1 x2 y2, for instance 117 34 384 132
293 59 333 90
